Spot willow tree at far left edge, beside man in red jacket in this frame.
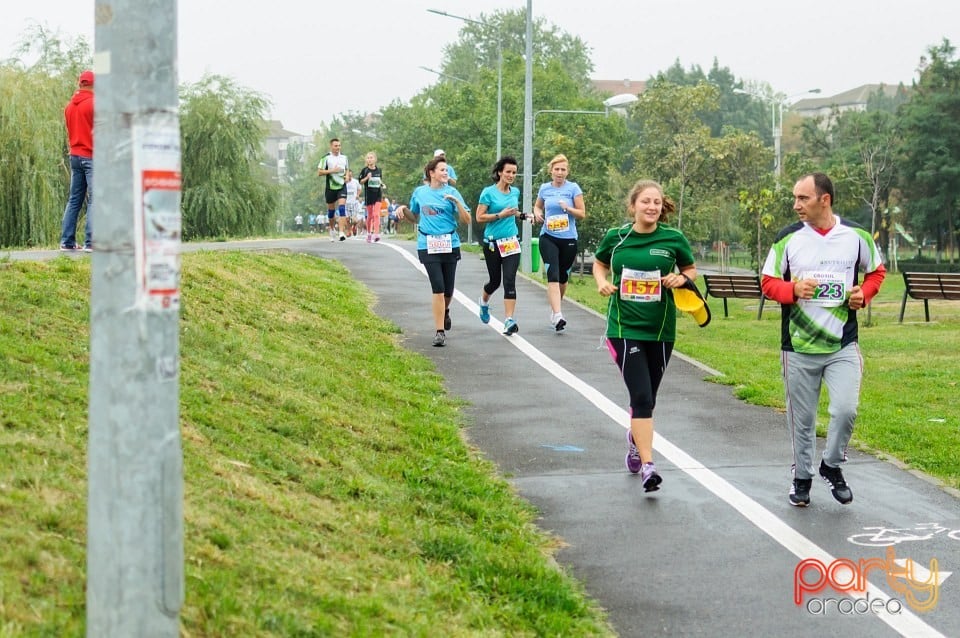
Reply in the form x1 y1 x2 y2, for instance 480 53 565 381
0 26 91 247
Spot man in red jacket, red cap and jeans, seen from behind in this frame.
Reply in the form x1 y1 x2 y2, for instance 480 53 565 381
60 71 93 252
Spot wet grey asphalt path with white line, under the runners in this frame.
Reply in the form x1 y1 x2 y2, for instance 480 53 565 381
9 237 960 637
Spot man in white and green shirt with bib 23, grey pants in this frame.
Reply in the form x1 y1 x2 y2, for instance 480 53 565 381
762 173 886 507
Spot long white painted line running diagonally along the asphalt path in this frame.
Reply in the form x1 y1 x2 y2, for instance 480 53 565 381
385 244 946 638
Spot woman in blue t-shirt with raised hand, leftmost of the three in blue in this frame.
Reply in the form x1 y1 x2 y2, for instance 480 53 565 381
397 157 470 347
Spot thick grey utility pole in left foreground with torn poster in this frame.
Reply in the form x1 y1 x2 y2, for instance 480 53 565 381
87 0 184 638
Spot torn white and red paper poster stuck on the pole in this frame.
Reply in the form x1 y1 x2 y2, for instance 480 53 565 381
133 121 182 312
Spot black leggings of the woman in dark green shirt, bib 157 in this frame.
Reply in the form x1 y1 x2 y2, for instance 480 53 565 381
607 337 673 419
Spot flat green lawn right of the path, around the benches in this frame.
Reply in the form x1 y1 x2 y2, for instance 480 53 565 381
567 274 960 488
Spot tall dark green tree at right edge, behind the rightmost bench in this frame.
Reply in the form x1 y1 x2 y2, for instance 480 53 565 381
900 39 960 261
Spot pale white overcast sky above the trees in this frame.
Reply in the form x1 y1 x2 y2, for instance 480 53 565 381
0 0 960 134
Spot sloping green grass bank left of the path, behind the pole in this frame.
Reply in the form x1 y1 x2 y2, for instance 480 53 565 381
0 253 613 637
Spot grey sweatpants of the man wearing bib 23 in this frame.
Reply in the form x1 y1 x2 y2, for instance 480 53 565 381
780 343 863 479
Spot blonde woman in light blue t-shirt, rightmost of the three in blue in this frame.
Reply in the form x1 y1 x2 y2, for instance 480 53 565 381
533 155 587 332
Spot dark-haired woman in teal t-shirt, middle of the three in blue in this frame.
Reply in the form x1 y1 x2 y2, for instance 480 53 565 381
477 156 523 336
